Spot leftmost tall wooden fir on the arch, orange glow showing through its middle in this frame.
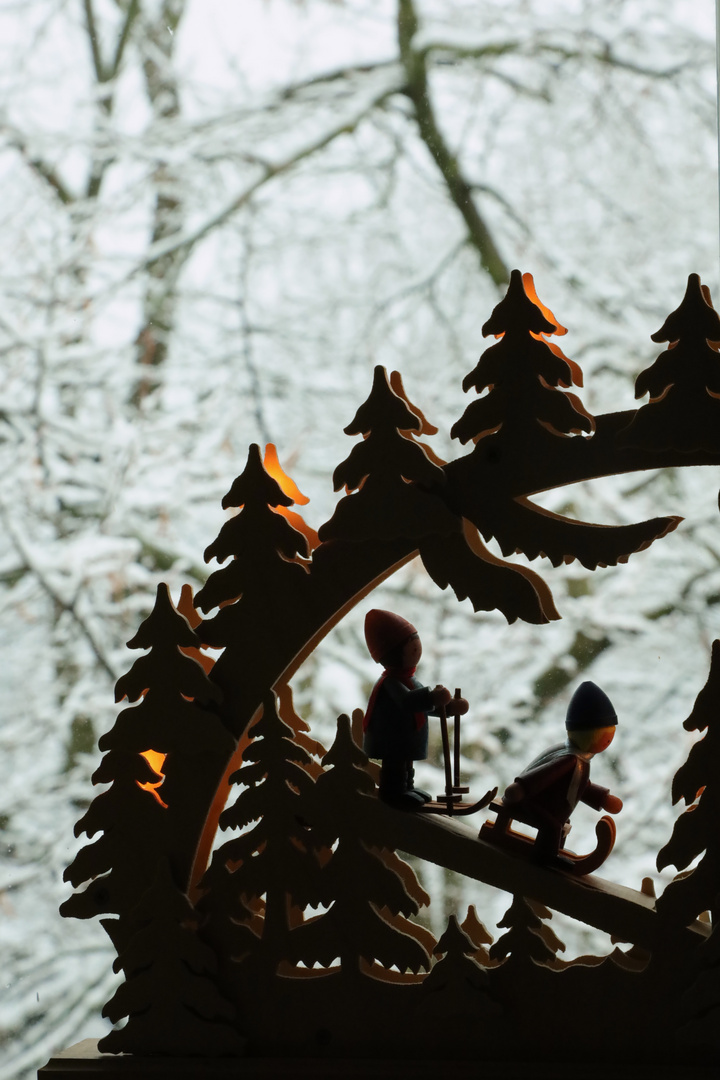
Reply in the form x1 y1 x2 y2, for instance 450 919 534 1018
62 584 233 918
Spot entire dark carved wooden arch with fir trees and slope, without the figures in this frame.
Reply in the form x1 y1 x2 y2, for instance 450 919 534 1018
49 271 720 1080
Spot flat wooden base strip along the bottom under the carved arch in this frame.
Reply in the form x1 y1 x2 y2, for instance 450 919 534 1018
38 1039 718 1080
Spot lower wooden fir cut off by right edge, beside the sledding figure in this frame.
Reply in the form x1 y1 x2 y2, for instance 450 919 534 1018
657 640 720 926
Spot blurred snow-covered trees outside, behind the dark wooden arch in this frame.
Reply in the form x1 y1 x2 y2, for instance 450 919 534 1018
0 0 720 1080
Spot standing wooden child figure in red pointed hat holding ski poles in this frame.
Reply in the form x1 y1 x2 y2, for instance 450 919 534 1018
363 608 467 810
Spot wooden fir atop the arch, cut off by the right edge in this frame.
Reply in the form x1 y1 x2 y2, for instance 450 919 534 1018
623 273 720 450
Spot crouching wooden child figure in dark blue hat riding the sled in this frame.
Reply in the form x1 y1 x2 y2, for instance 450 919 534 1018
502 681 623 862
